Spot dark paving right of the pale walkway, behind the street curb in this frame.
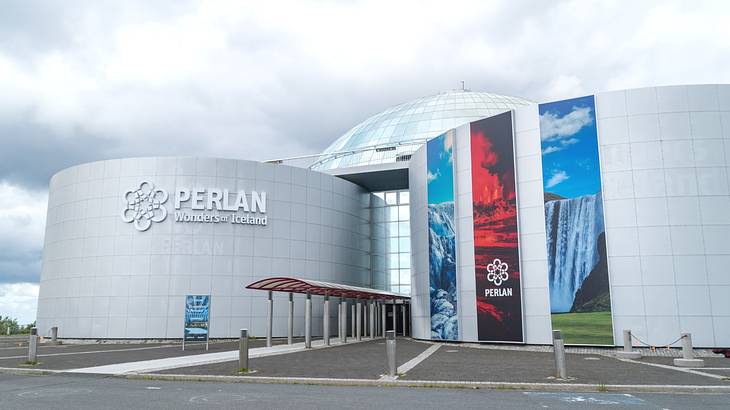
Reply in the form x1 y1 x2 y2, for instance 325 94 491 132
149 339 730 386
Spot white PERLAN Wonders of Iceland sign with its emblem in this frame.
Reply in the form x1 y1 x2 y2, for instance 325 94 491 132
122 181 268 231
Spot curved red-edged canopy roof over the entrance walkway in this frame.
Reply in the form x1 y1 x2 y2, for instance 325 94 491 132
246 278 410 300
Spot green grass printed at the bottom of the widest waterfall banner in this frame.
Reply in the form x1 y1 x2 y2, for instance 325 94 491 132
552 312 613 345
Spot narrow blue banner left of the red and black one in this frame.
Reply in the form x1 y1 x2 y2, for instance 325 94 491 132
426 131 459 340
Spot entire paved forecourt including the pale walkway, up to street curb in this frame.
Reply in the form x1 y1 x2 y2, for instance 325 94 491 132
0 338 730 392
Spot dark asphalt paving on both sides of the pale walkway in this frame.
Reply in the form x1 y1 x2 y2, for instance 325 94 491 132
0 338 730 386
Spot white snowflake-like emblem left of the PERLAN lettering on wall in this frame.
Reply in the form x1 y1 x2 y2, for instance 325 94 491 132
122 181 167 232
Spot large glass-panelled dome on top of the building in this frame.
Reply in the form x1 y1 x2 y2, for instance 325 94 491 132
311 91 532 170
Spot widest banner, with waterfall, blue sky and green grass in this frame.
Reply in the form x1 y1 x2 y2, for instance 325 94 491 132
539 95 613 344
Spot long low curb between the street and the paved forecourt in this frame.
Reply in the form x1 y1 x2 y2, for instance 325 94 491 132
121 373 730 394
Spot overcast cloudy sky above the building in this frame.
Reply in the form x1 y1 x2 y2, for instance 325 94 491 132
0 0 730 322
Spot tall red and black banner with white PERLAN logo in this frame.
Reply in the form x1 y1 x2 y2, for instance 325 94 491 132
470 112 523 342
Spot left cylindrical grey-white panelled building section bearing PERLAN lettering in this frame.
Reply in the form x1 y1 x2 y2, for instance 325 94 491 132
38 157 370 339
